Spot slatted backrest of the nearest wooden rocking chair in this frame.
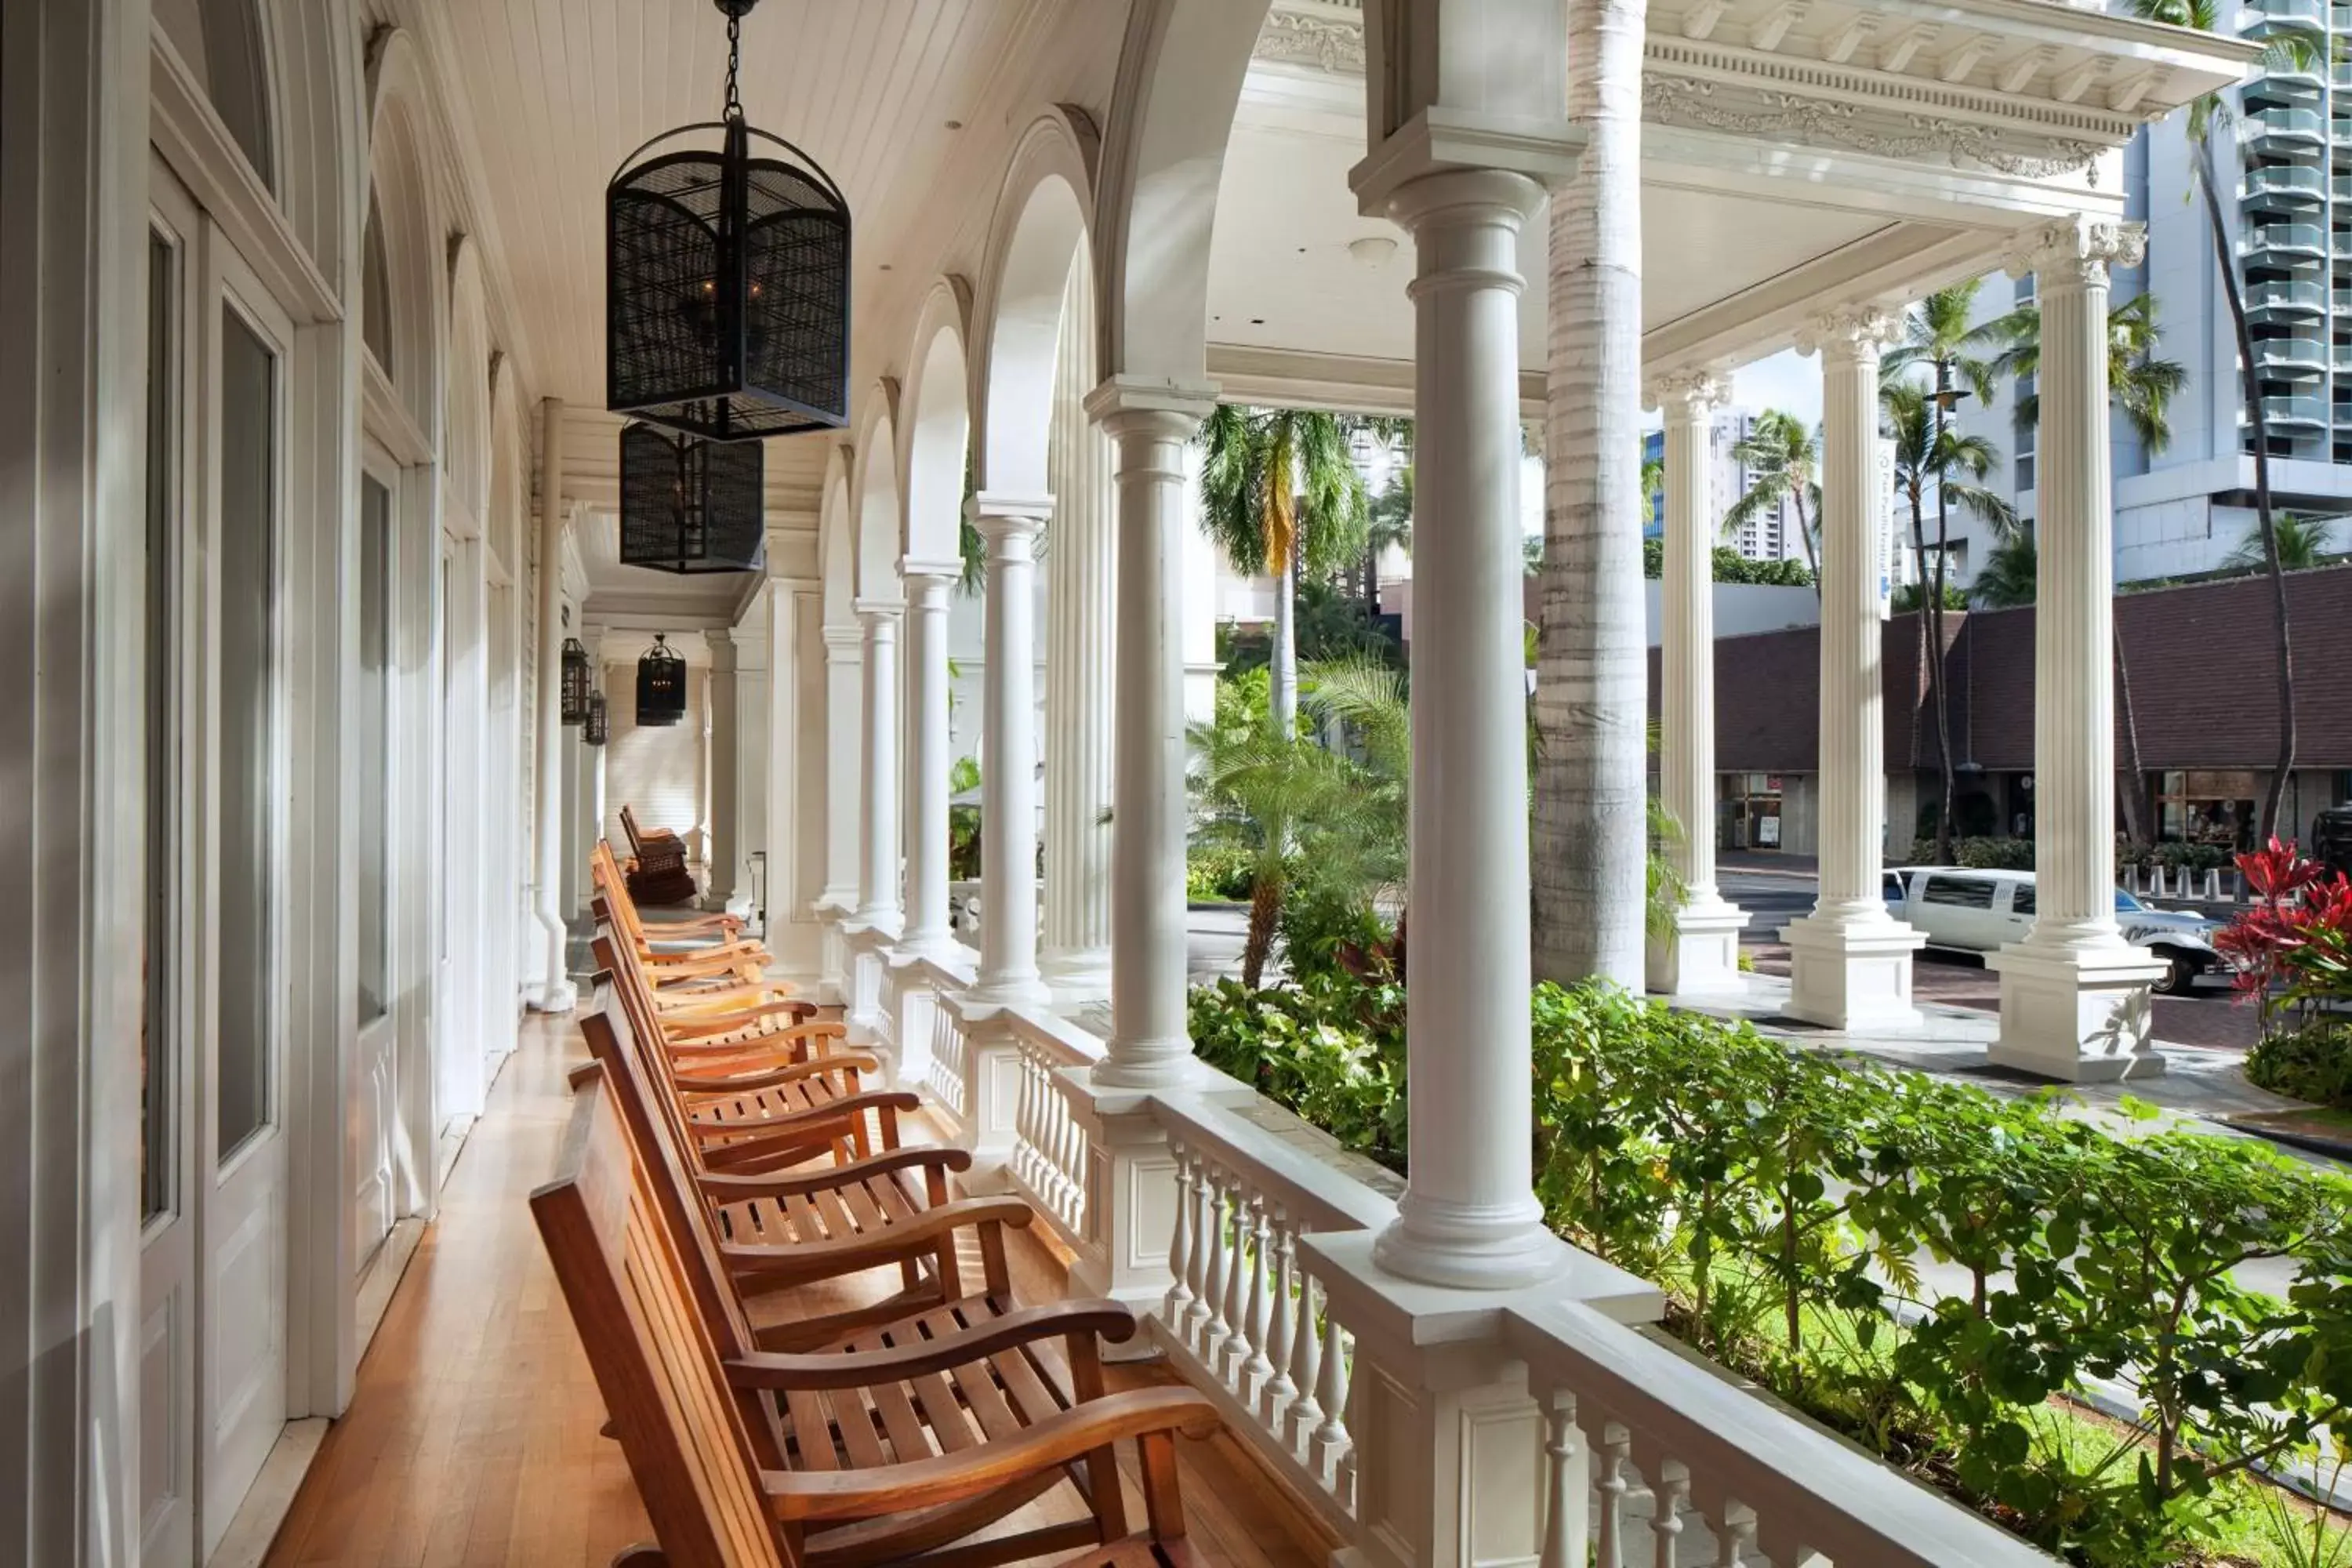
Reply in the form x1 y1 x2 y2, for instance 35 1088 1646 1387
532 1074 800 1568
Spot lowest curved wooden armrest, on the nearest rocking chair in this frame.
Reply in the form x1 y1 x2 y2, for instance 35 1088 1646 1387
760 1389 1218 1521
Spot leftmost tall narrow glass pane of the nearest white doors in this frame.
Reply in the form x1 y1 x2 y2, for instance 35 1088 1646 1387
139 235 179 1220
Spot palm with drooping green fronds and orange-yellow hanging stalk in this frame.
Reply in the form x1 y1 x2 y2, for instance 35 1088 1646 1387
1200 402 1371 736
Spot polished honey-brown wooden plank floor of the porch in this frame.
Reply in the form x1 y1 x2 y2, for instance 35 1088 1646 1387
266 1015 1338 1568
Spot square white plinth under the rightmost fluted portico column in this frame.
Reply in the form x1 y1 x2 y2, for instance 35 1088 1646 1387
1985 942 2166 1083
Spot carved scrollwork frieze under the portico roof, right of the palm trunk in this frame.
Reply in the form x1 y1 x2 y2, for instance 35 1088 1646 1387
1642 75 2105 186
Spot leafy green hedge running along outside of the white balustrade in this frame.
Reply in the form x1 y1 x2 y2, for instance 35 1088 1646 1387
1192 968 2352 1568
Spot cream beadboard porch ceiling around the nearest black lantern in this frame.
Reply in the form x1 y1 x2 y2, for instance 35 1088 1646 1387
426 0 1127 420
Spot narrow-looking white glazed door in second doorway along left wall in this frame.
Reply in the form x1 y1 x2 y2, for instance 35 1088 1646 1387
350 447 400 1272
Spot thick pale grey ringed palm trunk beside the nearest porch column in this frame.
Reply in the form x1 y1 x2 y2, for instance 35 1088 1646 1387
1534 0 1649 989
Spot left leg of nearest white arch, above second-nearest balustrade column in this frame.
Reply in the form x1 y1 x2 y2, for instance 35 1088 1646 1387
1094 0 1279 386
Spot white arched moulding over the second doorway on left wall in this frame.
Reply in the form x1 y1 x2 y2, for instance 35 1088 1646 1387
360 28 447 440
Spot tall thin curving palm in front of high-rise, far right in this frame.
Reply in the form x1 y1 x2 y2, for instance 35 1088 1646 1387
2126 0 2324 839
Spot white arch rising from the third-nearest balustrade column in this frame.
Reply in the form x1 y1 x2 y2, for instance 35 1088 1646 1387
974 108 1096 496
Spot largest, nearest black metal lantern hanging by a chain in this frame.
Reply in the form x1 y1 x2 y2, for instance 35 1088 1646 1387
604 0 849 442
